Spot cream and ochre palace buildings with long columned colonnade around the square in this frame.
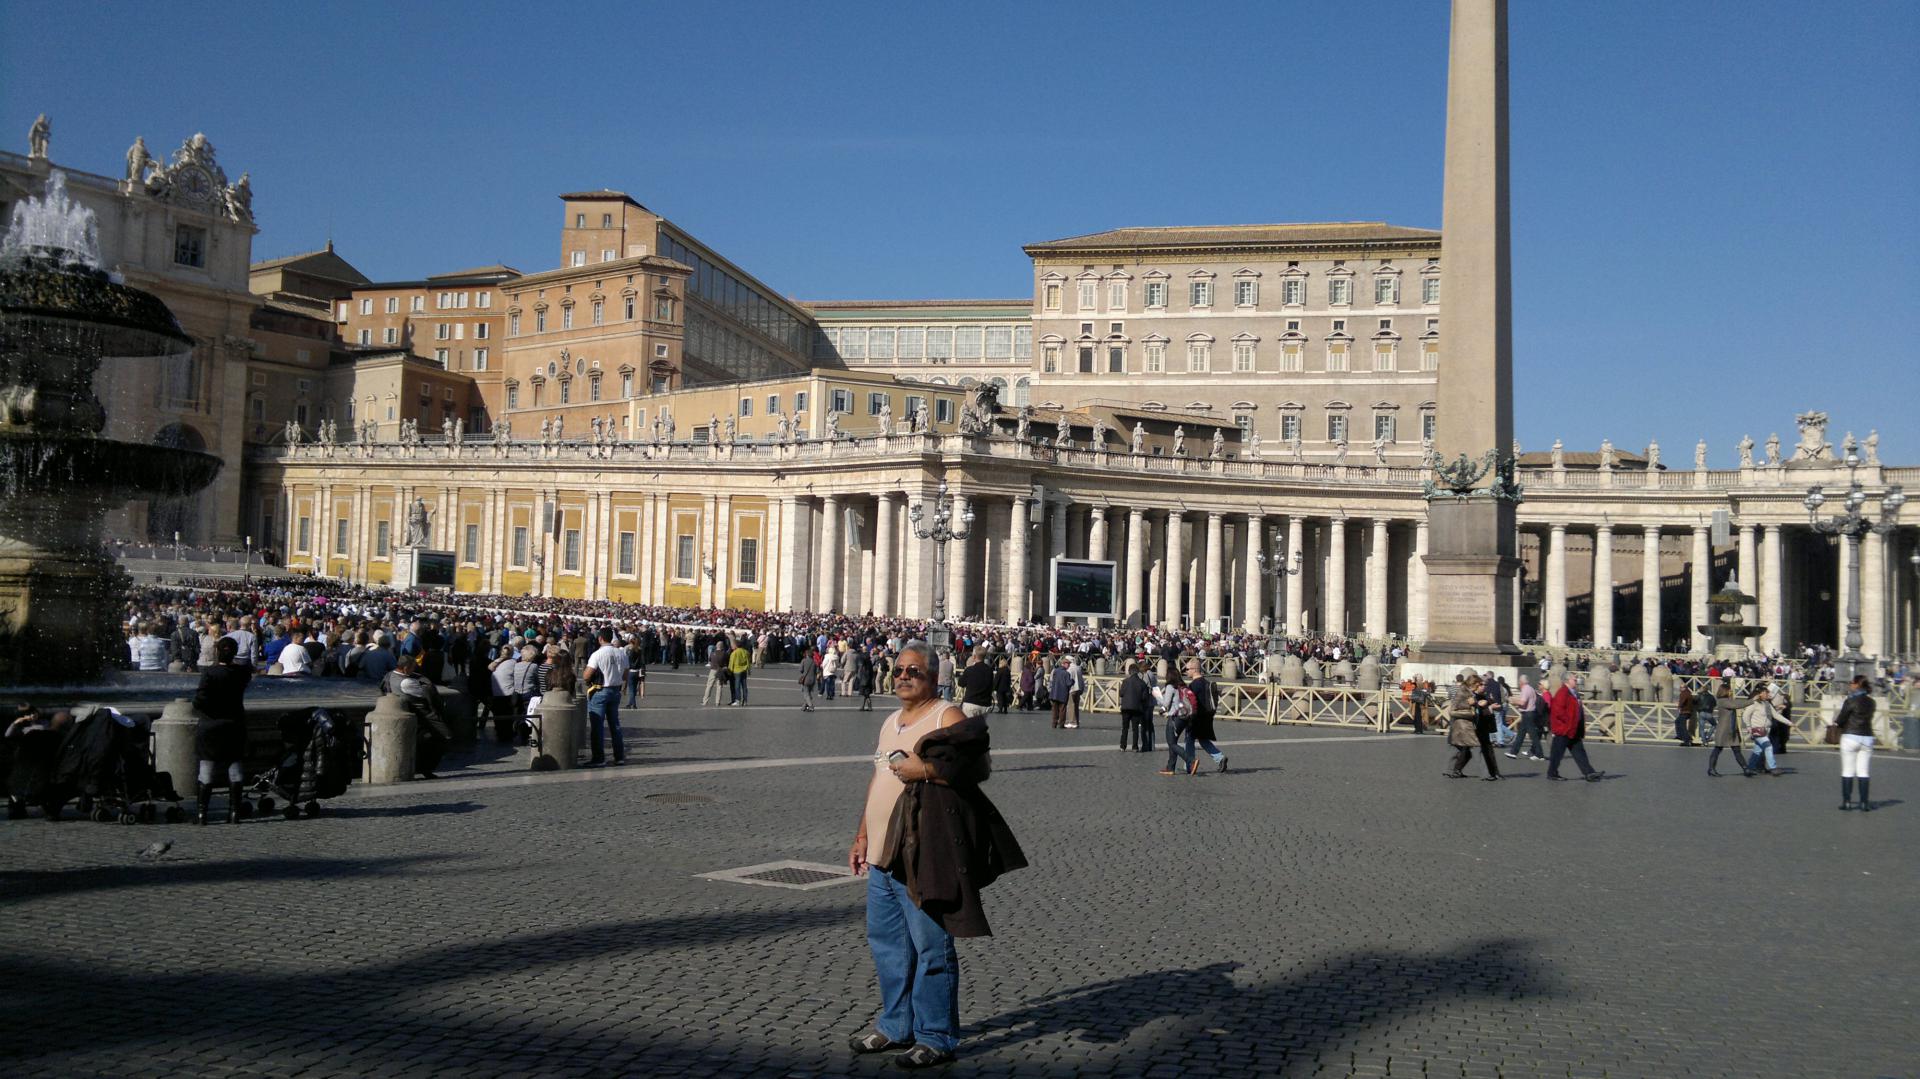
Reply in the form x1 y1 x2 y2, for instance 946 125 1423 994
0 121 1920 655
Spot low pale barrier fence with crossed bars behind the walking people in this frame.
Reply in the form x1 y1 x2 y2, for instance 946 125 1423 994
1081 674 1920 749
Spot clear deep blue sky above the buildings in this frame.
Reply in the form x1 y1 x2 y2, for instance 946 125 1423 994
0 0 1920 456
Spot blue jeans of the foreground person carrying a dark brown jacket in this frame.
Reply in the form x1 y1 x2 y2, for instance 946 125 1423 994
866 868 960 1052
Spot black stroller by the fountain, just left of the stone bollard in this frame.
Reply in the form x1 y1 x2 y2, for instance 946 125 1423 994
33 705 186 824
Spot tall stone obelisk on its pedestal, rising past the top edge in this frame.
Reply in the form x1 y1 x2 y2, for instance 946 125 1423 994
1421 0 1519 666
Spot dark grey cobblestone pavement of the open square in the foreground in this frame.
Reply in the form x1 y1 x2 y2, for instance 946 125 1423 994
0 670 1920 1077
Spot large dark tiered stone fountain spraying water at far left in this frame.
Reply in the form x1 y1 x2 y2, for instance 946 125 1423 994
0 171 221 685
